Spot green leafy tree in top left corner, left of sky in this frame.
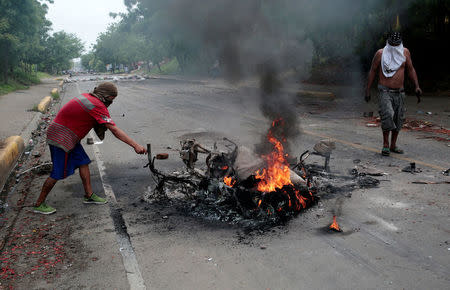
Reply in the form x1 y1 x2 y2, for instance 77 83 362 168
0 0 83 93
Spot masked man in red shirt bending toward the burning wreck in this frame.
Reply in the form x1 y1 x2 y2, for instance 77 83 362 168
33 82 147 214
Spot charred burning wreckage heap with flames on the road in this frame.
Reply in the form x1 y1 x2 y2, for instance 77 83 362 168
145 122 378 230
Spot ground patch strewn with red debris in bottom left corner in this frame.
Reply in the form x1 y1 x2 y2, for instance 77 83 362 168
0 210 87 289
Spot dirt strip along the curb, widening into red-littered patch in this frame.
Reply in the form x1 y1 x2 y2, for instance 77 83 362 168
0 112 88 289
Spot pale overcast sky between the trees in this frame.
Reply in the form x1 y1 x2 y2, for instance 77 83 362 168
47 0 126 51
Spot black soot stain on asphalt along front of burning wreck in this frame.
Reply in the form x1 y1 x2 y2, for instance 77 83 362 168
111 174 366 245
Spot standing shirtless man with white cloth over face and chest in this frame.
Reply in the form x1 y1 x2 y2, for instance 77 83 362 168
365 32 422 156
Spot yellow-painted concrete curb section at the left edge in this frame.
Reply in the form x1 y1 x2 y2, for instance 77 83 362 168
0 136 25 191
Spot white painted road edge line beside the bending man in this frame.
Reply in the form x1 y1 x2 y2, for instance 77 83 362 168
76 83 147 289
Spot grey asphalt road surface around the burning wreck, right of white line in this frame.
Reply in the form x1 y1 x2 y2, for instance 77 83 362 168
67 79 450 289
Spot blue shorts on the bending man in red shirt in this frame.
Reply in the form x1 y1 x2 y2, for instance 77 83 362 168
49 143 91 180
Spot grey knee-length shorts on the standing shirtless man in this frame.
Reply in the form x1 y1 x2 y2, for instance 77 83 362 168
378 85 406 131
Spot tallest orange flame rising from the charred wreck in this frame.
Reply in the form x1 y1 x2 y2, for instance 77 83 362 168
255 124 293 192
